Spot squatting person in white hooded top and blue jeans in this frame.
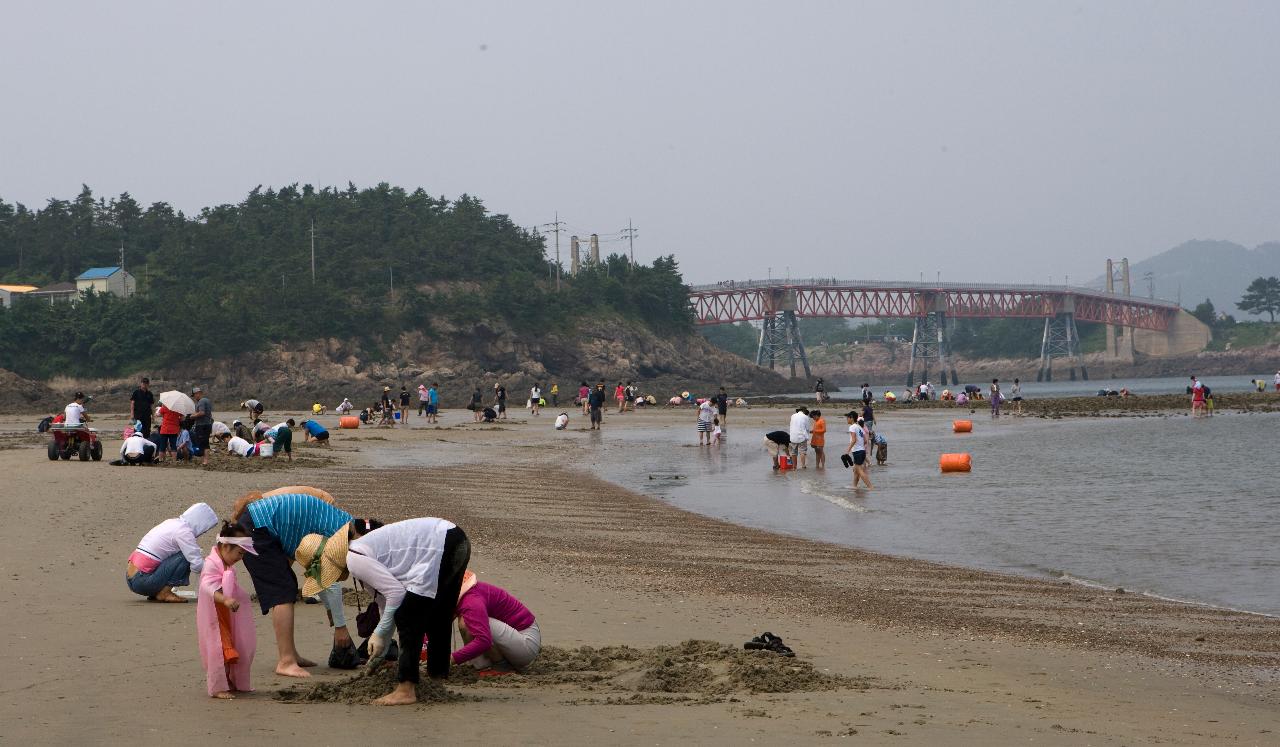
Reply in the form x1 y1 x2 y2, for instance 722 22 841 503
124 503 218 602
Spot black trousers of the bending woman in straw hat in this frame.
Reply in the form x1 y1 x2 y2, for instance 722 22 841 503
396 527 471 683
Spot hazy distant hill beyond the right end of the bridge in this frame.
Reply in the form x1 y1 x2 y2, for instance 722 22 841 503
1089 240 1280 321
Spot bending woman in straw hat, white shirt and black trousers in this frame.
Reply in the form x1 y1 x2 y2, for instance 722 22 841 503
300 517 471 706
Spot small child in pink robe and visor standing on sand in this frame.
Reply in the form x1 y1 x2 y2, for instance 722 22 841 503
196 523 257 698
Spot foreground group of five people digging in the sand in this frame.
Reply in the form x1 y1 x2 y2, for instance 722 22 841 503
125 486 541 705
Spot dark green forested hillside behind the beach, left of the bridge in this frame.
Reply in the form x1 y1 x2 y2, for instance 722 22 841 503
0 184 692 377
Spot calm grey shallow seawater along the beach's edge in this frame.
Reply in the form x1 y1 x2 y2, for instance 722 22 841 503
593 411 1280 614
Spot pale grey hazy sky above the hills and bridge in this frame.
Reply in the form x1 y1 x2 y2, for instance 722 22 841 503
0 0 1280 283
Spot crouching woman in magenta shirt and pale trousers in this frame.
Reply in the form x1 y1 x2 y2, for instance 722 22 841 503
453 573 543 672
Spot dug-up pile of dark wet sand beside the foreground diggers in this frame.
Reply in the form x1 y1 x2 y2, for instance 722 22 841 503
276 641 870 705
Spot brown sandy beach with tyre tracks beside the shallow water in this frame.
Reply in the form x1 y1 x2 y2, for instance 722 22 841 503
0 408 1280 744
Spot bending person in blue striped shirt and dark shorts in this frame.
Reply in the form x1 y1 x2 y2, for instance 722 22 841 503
230 492 366 677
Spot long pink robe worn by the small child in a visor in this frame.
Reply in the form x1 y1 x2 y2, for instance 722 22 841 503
196 544 257 695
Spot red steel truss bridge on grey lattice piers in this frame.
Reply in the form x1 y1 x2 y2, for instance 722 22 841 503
689 278 1180 385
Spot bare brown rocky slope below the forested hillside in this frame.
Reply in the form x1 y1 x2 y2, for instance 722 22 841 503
24 312 788 412
